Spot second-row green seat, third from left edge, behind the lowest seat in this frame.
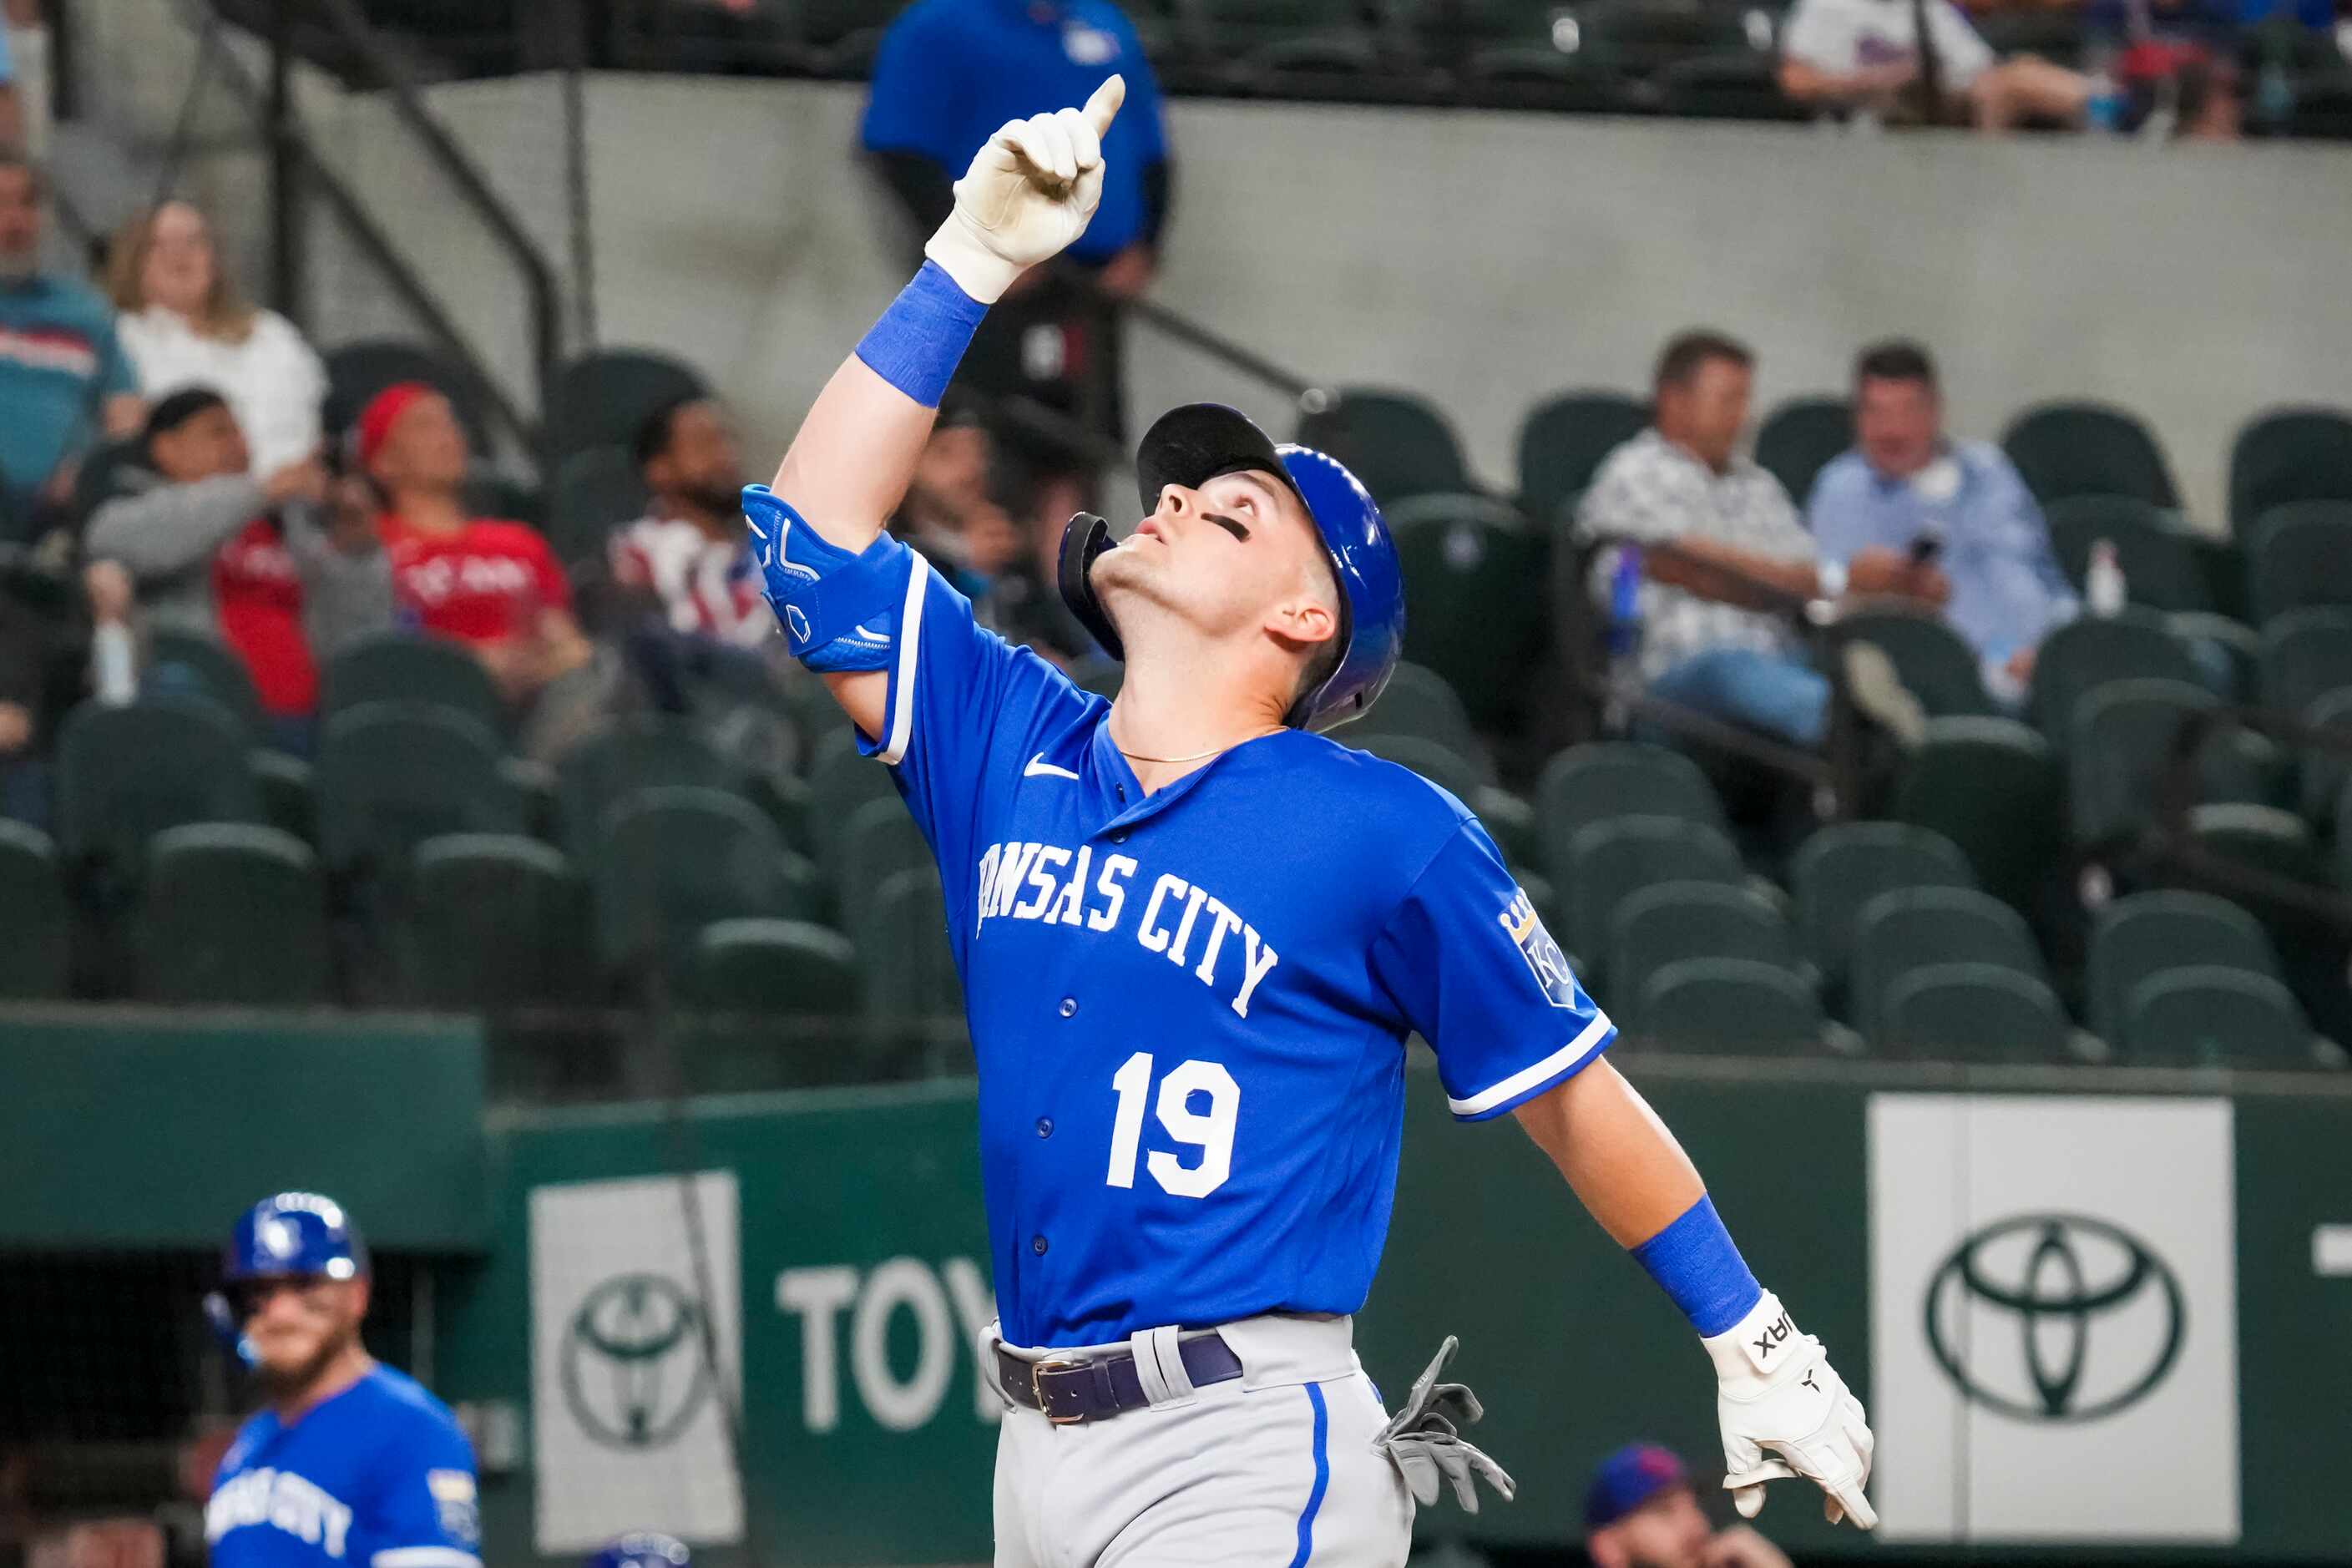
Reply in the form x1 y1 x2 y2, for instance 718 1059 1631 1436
593 785 818 980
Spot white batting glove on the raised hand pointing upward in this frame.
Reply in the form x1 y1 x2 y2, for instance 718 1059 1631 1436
922 75 1126 306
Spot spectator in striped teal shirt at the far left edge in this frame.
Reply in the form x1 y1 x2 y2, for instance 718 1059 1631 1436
0 148 146 539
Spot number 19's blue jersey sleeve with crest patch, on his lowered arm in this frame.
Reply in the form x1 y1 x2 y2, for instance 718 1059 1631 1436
1371 821 1616 1121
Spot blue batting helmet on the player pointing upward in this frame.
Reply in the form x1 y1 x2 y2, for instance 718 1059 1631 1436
1060 402 1404 729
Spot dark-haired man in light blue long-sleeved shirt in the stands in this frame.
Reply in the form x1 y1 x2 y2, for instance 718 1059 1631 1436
1806 341 2081 703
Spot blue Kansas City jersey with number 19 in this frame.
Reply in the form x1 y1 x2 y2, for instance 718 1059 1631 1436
861 534 1616 1345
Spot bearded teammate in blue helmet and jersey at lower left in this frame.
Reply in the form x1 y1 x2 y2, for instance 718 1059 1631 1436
205 1192 482 1568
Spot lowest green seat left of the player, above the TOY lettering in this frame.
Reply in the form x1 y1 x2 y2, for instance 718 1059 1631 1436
682 919 866 1093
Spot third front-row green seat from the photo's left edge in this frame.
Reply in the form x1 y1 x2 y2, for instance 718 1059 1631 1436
395 832 578 1011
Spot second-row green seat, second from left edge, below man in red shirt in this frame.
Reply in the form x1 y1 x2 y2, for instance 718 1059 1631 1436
315 703 529 896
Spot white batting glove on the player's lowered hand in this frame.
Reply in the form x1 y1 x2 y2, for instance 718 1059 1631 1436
1701 1291 1879 1530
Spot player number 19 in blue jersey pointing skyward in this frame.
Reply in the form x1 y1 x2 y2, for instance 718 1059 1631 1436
743 78 1874 1568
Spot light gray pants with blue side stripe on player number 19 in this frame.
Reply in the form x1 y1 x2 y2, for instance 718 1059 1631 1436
984 1317 1414 1568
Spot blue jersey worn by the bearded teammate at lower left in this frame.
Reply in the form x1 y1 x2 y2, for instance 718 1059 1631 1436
205 1366 482 1568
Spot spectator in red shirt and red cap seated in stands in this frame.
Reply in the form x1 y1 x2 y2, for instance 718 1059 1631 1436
357 381 590 703
